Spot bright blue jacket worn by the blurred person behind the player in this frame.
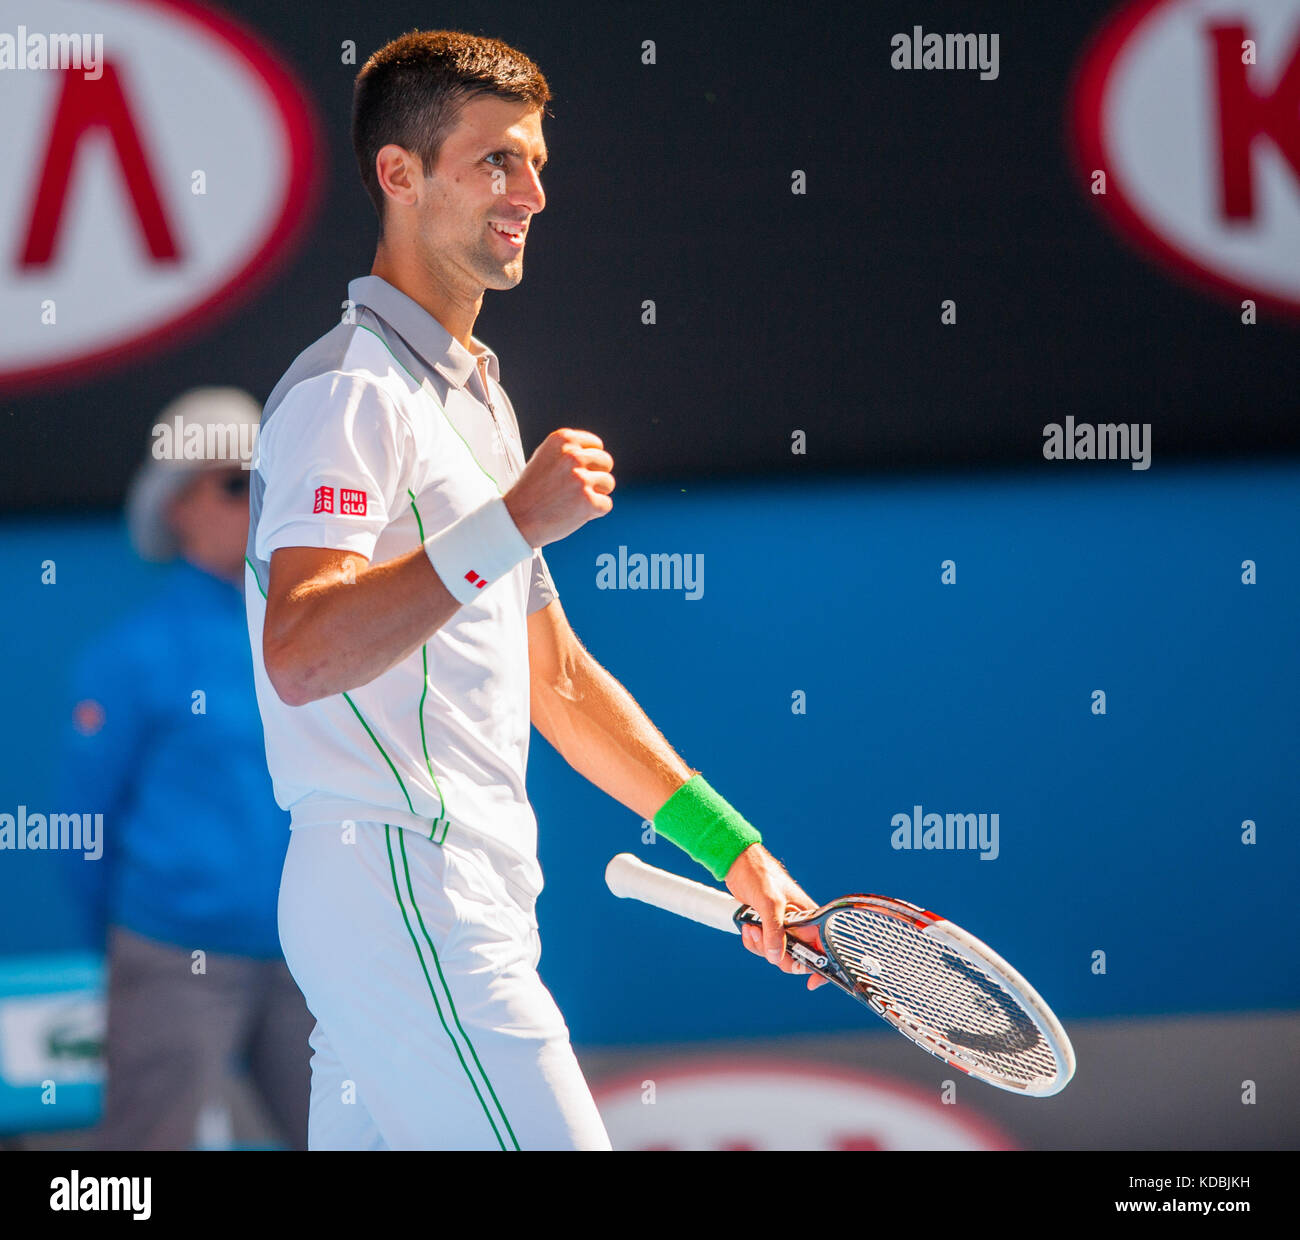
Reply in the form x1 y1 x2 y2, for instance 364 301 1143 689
61 563 289 958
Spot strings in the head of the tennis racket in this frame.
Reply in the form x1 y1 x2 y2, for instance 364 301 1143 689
824 909 1060 1085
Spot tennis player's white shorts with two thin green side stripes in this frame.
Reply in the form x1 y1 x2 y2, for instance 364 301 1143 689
280 823 610 1149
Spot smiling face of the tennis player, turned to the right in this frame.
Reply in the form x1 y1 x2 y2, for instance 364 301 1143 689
410 95 546 289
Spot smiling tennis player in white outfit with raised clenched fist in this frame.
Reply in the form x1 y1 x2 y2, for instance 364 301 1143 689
246 31 822 1149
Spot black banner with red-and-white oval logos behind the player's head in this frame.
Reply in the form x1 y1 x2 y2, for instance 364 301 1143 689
0 0 1300 510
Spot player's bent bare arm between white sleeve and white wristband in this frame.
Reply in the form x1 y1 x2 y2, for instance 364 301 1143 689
263 549 460 706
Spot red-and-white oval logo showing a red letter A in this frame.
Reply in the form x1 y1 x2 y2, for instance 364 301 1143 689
0 0 317 387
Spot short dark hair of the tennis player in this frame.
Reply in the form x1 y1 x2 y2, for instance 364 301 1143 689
352 30 551 231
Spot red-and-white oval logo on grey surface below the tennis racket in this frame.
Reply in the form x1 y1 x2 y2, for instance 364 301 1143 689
593 1055 1015 1150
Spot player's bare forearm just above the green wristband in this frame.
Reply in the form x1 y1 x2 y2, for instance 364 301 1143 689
533 654 694 819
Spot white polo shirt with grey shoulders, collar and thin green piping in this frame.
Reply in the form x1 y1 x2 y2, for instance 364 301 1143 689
244 276 556 873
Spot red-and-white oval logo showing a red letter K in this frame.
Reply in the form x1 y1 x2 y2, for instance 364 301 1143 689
1074 0 1300 313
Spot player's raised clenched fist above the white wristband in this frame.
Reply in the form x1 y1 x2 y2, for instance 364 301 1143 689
506 426 614 547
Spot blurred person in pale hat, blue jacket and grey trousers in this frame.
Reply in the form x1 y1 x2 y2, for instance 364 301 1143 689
64 387 313 1149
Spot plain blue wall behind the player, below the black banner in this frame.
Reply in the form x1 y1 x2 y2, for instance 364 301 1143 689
0 463 1300 1044
